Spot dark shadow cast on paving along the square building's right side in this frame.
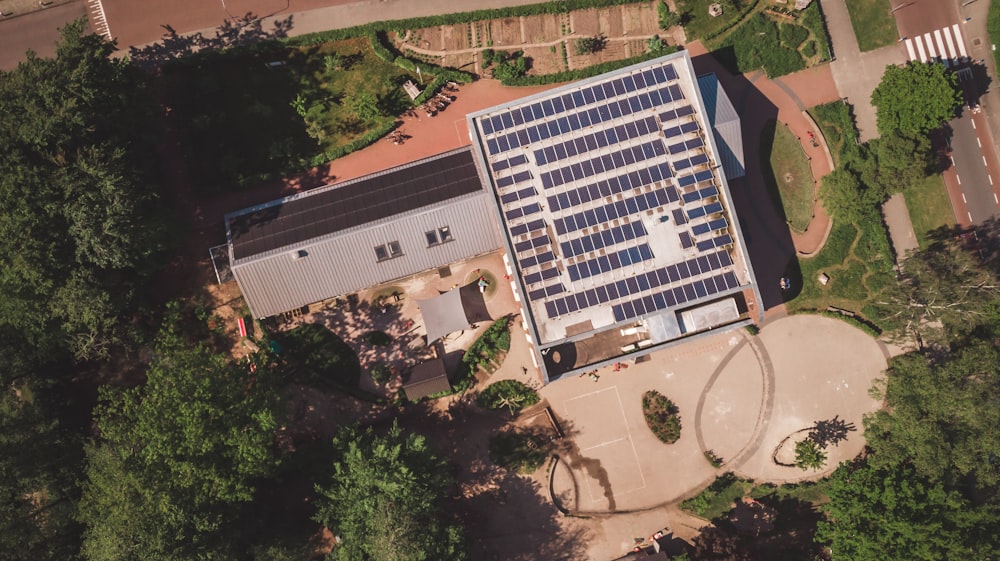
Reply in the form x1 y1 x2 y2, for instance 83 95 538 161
692 48 802 309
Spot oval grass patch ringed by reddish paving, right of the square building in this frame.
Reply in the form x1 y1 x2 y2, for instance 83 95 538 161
764 120 814 232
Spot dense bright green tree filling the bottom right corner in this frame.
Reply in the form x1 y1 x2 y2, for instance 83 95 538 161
816 464 1000 561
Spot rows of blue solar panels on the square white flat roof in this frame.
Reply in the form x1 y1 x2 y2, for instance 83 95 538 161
473 58 740 332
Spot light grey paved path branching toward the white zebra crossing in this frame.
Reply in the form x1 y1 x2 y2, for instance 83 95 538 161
820 0 906 142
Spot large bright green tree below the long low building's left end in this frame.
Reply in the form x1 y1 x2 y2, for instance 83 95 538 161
80 308 278 560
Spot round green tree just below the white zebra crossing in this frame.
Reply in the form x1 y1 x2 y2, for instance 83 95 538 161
872 61 962 134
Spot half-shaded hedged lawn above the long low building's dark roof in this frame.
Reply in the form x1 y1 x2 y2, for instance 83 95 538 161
164 38 416 192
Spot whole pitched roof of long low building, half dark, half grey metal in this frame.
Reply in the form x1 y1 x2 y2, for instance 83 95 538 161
227 148 502 318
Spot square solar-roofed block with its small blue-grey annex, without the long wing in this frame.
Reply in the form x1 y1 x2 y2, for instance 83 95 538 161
468 51 760 381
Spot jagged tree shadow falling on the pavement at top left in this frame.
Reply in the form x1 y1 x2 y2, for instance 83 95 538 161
129 12 293 70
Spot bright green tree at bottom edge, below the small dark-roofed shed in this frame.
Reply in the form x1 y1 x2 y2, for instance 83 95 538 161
315 425 465 561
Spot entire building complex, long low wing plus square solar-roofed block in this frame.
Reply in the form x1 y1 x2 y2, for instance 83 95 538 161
226 51 762 381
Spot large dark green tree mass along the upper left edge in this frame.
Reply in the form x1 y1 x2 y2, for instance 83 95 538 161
0 19 163 375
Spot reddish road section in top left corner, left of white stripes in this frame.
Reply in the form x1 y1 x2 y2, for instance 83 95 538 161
0 0 90 70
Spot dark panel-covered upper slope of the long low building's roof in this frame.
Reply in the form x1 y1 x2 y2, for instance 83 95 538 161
228 149 483 259
